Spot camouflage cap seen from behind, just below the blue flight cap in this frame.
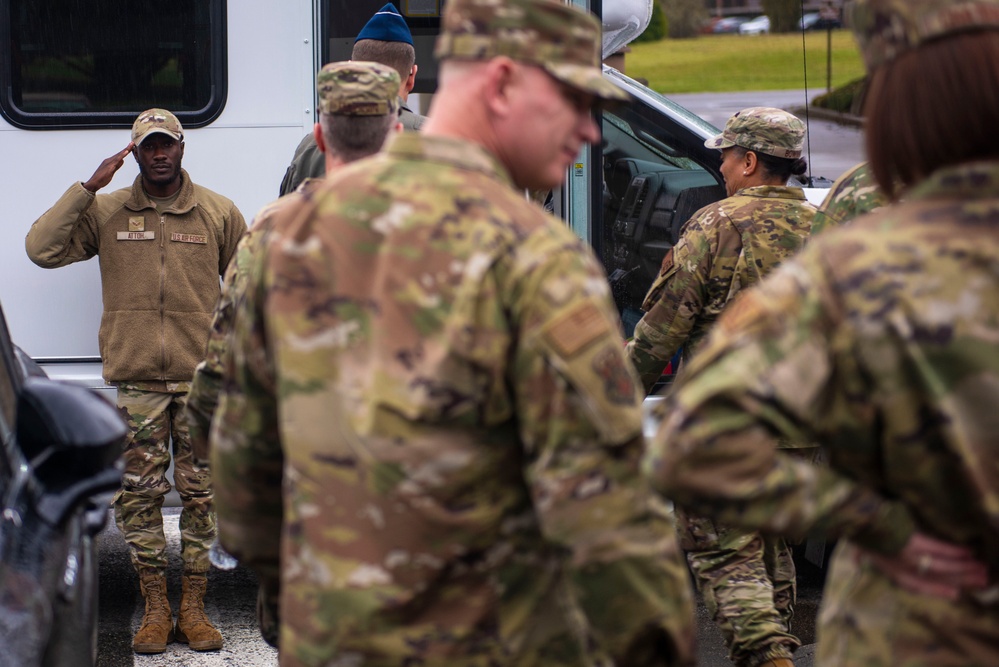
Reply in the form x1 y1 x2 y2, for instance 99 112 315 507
316 60 401 116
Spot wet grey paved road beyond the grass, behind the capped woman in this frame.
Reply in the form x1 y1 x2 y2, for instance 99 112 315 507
669 89 864 185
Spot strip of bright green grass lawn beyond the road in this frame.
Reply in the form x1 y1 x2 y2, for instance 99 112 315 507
625 30 864 94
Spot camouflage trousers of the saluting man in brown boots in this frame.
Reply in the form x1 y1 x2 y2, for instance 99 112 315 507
114 387 216 573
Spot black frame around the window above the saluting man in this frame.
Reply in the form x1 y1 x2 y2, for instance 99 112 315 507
0 0 228 130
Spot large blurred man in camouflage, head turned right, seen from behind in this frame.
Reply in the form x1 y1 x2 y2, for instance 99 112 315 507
211 0 693 667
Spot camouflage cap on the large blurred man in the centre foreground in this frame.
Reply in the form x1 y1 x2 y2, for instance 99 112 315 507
434 0 628 100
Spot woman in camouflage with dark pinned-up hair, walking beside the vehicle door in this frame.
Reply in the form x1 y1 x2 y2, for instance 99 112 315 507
627 107 817 667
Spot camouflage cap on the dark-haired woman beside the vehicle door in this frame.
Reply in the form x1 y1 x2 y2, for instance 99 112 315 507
704 107 805 160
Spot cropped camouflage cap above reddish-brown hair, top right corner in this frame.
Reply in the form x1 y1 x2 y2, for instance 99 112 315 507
845 0 999 70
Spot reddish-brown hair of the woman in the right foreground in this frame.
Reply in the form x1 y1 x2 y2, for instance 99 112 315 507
864 29 999 196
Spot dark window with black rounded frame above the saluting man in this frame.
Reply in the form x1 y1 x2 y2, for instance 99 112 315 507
0 0 226 129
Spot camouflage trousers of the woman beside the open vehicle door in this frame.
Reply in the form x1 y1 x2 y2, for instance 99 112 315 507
676 447 818 667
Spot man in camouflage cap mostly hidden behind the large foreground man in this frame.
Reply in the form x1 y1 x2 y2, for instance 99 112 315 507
187 61 400 644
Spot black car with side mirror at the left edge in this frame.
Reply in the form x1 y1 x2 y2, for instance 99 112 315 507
0 309 128 667
